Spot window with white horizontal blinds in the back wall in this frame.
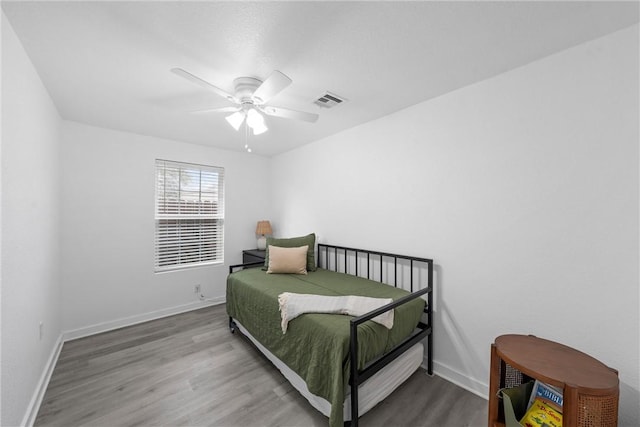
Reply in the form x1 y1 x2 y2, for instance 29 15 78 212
155 160 224 271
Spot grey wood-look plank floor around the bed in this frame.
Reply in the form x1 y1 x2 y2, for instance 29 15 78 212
35 305 487 427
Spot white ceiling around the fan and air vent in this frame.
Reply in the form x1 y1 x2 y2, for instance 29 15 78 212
2 1 638 156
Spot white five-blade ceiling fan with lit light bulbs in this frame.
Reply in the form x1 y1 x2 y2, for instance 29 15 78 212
171 68 319 135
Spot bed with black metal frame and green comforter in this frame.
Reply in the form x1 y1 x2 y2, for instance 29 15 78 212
227 241 433 427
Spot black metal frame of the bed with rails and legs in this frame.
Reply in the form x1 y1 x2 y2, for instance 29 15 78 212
229 243 433 427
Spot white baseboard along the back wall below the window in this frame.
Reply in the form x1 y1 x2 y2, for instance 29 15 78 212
63 297 225 341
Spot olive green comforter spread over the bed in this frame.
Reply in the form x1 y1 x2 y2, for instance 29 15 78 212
227 268 425 427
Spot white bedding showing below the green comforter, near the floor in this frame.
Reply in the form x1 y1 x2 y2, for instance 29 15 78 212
234 319 424 421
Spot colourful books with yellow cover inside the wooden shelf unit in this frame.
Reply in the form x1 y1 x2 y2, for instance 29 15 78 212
520 380 562 427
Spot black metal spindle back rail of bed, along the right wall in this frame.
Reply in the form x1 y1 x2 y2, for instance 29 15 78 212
316 243 433 292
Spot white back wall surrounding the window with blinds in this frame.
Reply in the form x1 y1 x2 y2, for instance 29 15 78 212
62 121 270 338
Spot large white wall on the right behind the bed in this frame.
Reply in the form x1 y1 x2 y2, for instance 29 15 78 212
272 26 640 425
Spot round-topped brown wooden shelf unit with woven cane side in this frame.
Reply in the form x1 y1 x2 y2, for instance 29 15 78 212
488 335 620 427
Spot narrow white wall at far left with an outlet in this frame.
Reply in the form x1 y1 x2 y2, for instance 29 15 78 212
0 13 61 426
